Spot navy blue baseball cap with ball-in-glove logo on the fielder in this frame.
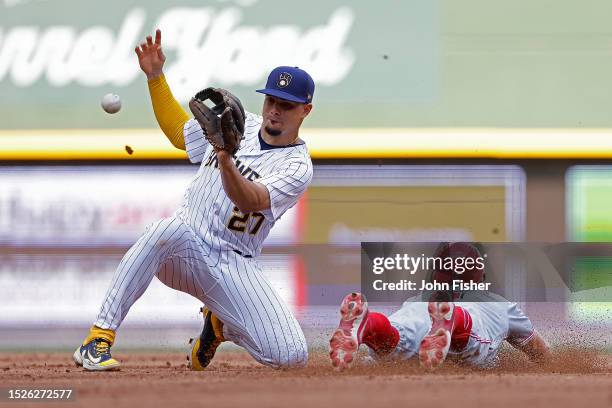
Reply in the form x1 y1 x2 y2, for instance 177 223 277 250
257 67 314 103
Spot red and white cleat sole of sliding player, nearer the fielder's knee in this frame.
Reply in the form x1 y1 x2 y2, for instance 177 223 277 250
329 292 368 370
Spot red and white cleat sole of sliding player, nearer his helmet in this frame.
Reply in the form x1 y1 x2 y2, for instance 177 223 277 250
419 302 455 370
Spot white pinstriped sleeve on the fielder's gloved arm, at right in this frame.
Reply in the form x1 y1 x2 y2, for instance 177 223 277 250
254 158 312 222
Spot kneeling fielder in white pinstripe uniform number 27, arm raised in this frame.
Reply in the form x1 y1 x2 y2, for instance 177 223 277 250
73 30 314 370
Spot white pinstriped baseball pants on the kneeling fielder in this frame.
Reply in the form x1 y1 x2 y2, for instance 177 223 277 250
94 217 308 367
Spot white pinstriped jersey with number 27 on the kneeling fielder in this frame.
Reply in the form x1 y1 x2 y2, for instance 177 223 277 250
177 112 313 259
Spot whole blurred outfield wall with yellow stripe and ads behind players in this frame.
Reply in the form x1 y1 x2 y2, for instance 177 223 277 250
0 0 612 349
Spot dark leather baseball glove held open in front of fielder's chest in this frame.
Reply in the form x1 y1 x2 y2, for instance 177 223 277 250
189 88 245 156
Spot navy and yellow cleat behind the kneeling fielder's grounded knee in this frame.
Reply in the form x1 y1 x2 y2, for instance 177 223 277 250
187 308 225 371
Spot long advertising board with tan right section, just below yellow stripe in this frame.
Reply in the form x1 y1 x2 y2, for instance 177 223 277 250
0 164 525 248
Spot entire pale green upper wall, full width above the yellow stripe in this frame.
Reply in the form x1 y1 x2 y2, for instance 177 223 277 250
5 0 612 131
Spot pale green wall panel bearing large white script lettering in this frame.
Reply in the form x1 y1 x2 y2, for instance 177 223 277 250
0 0 439 129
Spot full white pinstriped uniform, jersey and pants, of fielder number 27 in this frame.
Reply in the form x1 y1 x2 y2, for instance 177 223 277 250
94 107 312 367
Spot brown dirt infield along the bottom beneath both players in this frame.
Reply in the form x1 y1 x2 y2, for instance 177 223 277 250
0 351 612 408
